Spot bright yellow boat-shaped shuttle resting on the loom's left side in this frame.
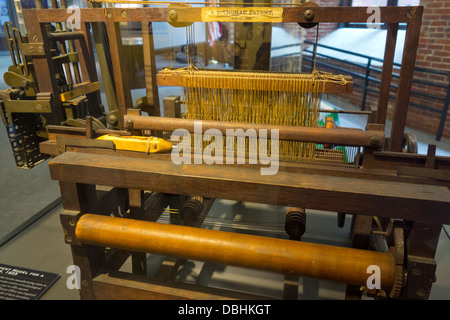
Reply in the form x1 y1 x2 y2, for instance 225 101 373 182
97 134 172 153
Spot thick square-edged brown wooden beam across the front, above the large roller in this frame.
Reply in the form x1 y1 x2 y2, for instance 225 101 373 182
49 152 450 224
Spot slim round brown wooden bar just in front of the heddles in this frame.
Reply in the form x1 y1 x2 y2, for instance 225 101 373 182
124 115 384 148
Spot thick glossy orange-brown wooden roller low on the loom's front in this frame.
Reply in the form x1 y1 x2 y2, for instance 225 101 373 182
75 214 395 290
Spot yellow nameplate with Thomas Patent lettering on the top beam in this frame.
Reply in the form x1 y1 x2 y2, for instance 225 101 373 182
202 7 283 22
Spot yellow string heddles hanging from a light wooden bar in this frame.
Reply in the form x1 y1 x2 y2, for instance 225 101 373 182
157 66 353 162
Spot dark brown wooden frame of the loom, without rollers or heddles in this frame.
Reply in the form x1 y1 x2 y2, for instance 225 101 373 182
19 6 450 299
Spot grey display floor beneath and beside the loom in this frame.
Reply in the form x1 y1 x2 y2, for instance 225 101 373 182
0 190 450 300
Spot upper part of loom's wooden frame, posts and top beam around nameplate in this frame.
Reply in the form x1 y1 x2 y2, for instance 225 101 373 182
24 4 423 152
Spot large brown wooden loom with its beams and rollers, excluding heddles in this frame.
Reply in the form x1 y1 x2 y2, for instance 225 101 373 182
3 4 450 299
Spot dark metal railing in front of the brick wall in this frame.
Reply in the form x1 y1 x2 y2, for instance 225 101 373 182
296 41 450 141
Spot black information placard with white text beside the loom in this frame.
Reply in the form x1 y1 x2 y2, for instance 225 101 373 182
0 264 59 300
